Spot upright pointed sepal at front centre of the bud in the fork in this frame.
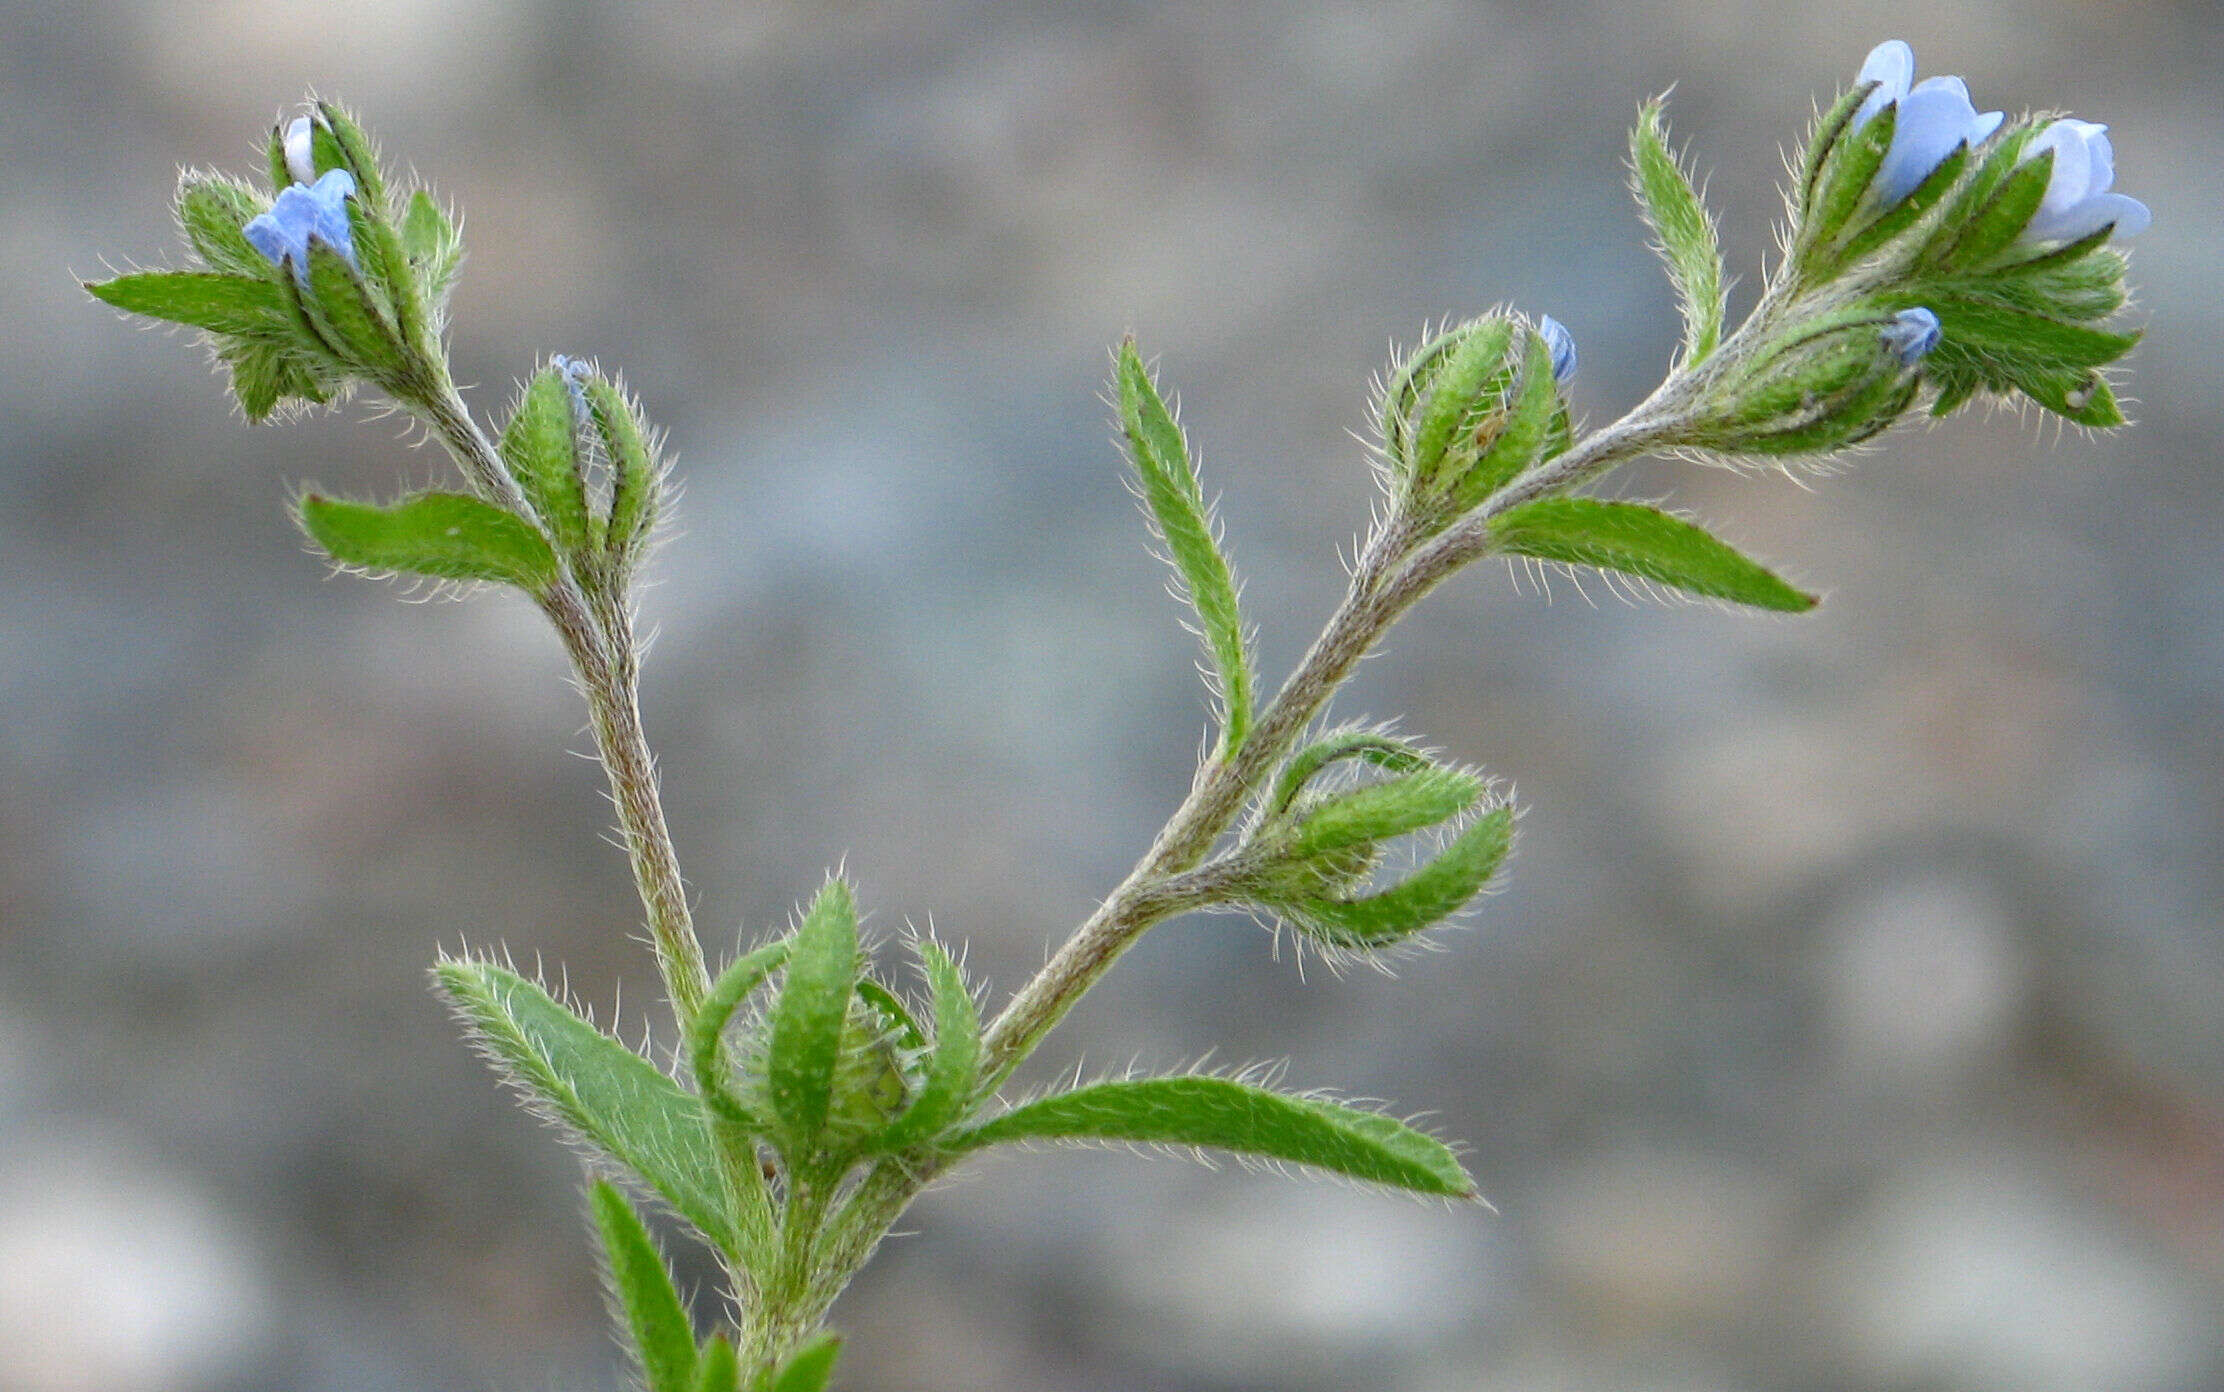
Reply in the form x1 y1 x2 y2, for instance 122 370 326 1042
765 881 858 1163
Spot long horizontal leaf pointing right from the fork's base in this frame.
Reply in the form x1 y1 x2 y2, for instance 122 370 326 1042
954 1076 1475 1199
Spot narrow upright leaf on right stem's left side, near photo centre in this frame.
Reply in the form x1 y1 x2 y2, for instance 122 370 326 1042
1119 338 1252 752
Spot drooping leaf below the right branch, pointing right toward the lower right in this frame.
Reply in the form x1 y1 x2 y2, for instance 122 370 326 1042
1490 498 1817 614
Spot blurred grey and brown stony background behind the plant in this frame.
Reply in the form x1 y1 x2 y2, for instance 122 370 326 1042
0 0 2224 1392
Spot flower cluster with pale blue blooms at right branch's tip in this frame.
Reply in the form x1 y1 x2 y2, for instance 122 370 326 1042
1752 40 2153 429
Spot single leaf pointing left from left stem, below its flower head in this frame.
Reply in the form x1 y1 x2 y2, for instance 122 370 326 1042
300 494 556 594
